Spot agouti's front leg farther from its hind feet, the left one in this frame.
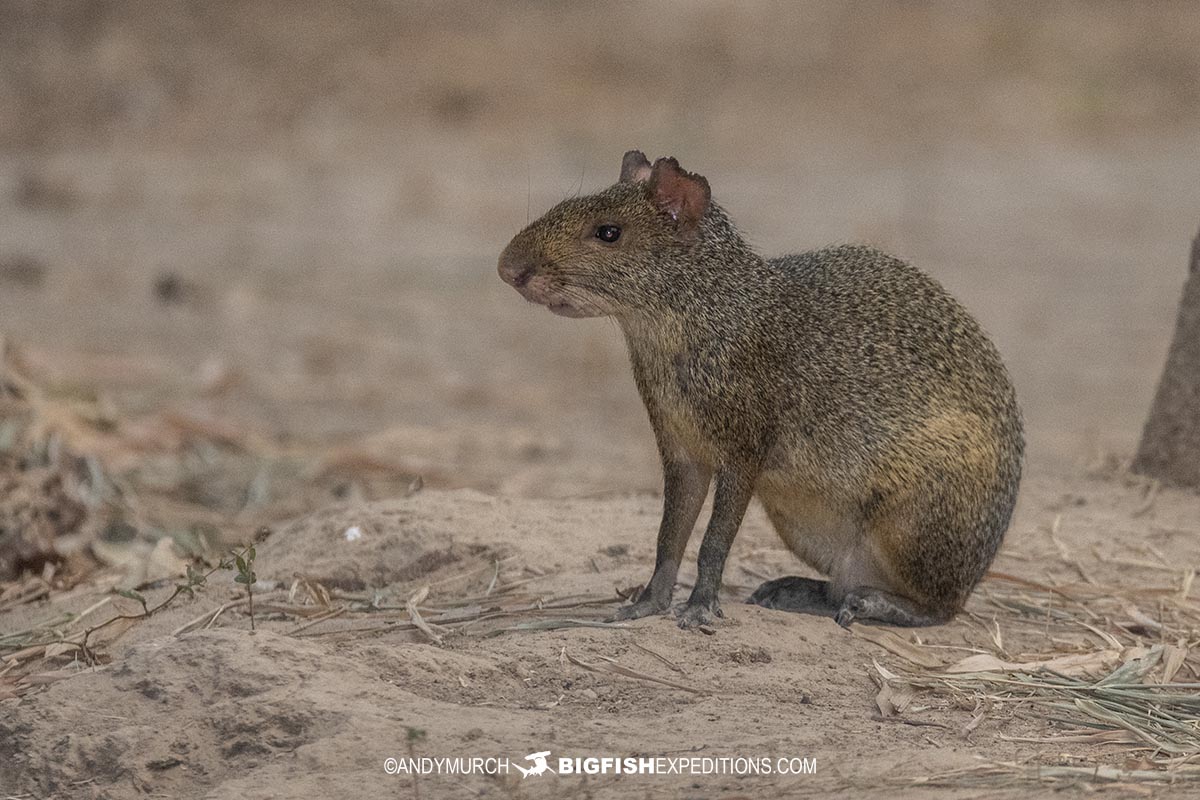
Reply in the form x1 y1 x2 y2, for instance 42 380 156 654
613 459 713 620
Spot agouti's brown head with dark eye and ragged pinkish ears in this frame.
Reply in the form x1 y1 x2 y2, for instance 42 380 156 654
499 150 730 317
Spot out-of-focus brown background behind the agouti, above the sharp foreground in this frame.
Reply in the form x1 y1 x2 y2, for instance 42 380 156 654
0 0 1200 495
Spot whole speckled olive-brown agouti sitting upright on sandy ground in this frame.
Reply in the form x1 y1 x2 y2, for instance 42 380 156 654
499 151 1024 627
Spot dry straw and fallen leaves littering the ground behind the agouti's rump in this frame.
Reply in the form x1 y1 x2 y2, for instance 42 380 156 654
857 565 1200 787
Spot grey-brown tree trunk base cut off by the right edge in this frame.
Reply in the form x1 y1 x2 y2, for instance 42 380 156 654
1133 225 1200 488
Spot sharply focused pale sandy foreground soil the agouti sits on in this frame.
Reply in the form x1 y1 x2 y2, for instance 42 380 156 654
7 474 1200 798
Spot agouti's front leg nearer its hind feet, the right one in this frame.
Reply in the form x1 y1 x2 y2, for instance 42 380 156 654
676 467 755 627
